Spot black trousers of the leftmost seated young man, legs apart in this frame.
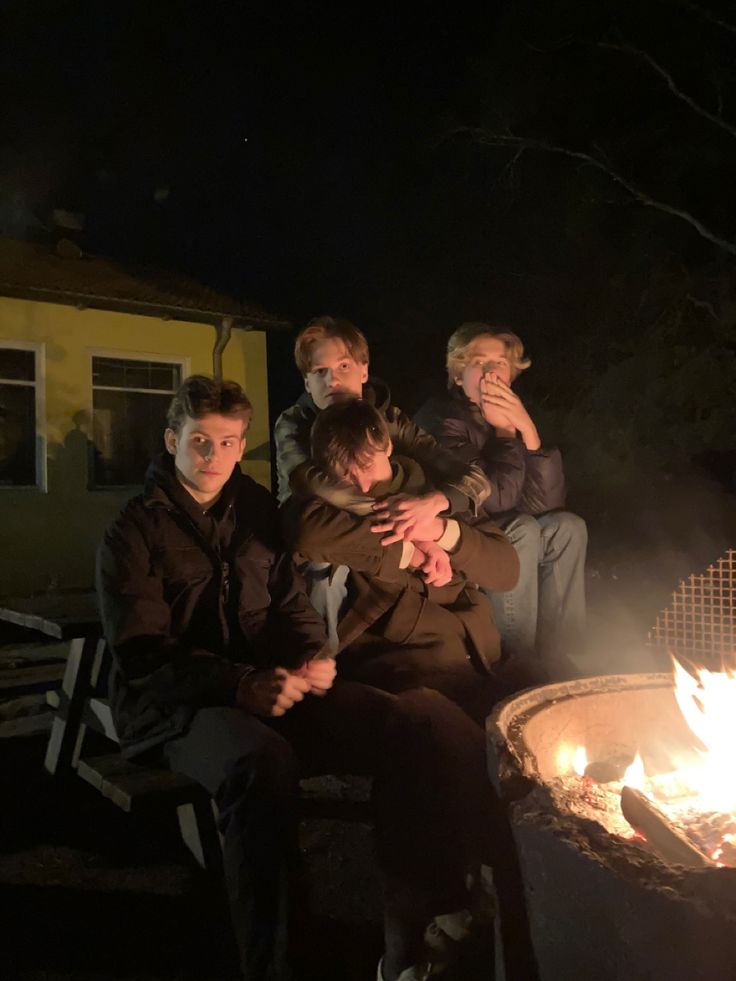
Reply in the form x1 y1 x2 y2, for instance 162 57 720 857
163 679 492 981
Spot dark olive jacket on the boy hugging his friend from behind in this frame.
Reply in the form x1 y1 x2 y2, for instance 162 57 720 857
274 379 488 514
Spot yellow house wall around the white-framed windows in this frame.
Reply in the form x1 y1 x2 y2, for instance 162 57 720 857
0 297 270 596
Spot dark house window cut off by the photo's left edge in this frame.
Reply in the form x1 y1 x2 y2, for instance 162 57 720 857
0 341 41 487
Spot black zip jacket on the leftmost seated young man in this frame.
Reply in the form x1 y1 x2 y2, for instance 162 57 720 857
97 454 325 755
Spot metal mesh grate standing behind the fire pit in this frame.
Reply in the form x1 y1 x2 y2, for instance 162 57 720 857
648 549 736 669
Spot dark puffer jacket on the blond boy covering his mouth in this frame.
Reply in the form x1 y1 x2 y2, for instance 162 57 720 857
414 386 565 521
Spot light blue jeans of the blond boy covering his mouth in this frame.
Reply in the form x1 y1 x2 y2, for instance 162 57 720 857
488 511 588 679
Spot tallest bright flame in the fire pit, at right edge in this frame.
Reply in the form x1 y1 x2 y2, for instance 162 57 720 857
672 658 736 813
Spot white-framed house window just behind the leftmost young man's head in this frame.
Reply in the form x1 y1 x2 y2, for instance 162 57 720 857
92 356 182 487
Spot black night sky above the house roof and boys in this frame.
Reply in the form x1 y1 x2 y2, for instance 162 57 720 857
0 0 736 436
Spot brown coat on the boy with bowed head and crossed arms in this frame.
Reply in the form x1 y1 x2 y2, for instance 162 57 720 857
286 499 519 670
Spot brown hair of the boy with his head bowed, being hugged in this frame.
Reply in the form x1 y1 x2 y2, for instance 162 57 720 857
311 399 391 477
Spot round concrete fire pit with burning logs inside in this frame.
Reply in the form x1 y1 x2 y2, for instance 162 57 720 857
487 674 736 981
